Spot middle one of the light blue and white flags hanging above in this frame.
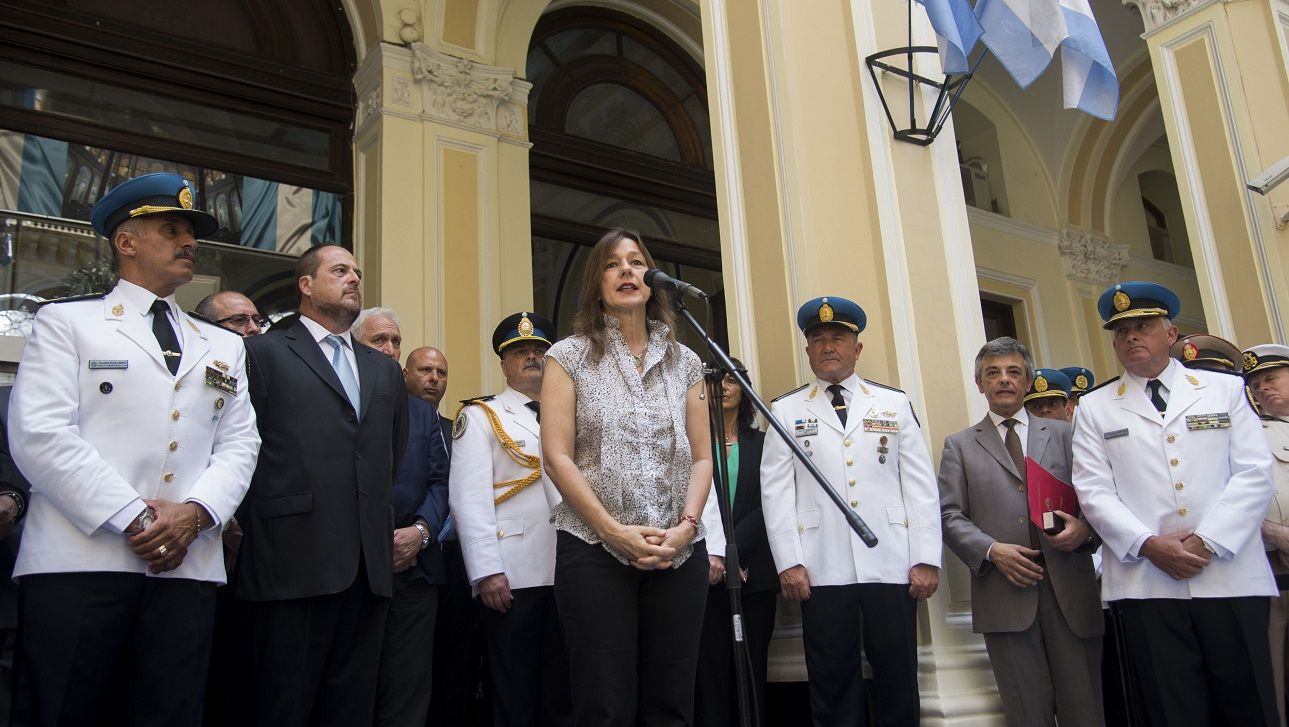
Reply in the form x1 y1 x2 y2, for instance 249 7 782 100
976 0 1070 89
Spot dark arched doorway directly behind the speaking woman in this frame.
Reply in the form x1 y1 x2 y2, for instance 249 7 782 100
526 8 727 354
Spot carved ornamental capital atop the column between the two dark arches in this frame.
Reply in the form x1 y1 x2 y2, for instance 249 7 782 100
411 43 532 139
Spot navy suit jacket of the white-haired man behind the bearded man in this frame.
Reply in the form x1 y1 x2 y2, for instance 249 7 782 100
393 396 447 584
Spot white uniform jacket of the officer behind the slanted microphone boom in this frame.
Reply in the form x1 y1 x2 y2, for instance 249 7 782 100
761 375 942 585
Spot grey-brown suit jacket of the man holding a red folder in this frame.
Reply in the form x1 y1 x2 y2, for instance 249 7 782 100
940 415 1105 638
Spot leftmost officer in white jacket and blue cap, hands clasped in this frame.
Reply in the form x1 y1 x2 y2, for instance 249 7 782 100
9 174 259 726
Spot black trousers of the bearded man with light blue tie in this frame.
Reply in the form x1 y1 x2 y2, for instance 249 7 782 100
233 561 391 727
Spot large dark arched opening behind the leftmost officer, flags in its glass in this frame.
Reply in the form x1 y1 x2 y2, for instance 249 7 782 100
0 0 356 335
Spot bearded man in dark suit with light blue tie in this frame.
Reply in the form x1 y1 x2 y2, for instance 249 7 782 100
236 245 407 727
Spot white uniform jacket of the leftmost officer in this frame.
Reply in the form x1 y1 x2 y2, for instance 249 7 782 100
9 282 259 583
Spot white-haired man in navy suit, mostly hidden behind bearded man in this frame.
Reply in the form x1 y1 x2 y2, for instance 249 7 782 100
352 308 447 727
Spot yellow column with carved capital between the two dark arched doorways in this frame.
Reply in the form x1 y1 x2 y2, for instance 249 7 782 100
354 28 532 402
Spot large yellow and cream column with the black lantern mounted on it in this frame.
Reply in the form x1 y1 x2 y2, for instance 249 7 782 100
703 0 1002 724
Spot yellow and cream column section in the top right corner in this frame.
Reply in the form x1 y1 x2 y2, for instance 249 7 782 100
1124 0 1289 347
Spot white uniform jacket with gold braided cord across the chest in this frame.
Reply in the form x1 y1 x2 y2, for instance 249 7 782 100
447 387 559 594
